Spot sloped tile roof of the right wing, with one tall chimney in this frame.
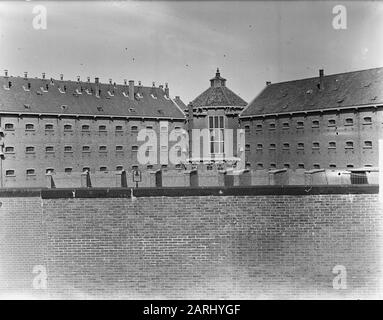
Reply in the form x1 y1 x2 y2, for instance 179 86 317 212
240 68 383 117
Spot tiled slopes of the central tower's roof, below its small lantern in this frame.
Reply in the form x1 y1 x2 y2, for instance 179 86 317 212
192 86 247 107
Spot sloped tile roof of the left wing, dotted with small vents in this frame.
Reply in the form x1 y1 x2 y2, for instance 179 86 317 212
0 77 185 118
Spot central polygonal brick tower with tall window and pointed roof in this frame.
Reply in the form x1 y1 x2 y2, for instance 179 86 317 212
185 69 247 164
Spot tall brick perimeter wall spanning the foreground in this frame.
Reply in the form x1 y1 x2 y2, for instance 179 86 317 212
0 188 383 299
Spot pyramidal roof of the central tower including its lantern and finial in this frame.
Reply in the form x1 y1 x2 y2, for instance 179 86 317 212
191 69 247 107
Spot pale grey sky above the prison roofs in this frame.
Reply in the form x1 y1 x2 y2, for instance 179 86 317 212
0 1 383 104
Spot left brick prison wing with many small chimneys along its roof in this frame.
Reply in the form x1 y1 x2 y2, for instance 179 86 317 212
0 71 185 187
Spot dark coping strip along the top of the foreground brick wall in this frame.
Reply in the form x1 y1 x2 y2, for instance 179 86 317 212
0 185 379 199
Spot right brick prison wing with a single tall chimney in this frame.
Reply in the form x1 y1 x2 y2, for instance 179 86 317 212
239 68 383 170
